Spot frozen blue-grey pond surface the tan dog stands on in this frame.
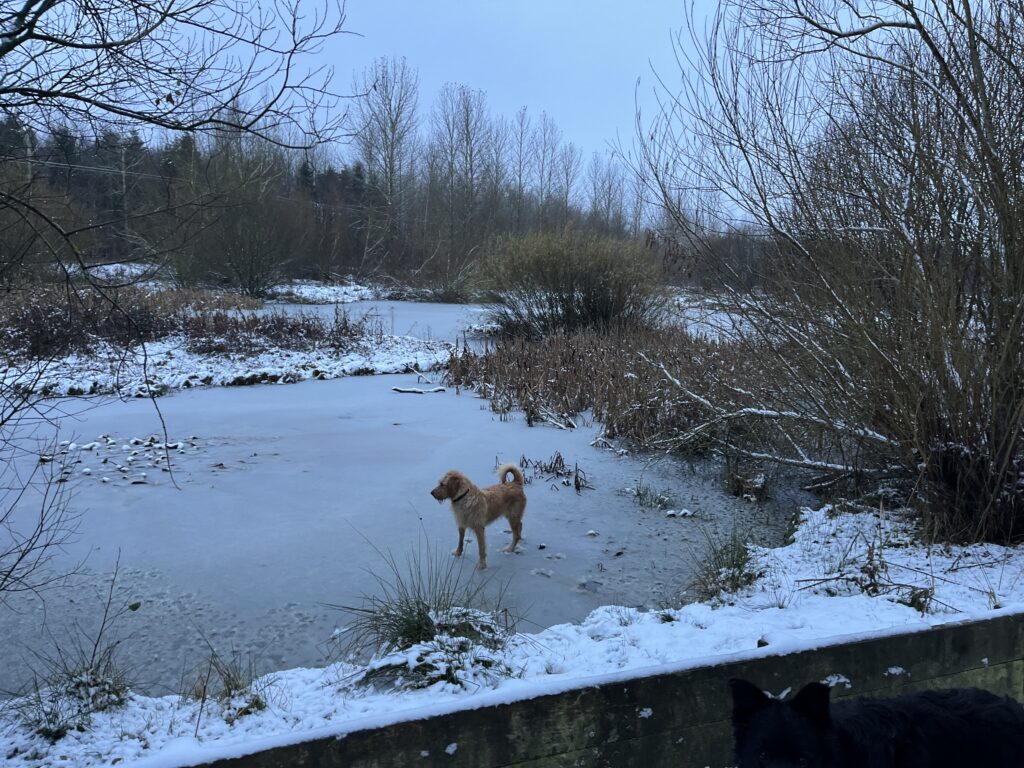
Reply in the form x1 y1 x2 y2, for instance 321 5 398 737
0 302 803 692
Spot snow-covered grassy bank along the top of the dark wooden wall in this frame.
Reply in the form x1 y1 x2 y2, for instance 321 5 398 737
0 505 1024 768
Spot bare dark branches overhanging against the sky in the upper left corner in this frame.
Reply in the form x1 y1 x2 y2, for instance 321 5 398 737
0 0 344 140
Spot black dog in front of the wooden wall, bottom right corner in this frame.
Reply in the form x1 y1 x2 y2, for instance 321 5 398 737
729 680 1024 768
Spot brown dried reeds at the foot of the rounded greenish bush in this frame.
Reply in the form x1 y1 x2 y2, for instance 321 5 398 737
445 327 763 454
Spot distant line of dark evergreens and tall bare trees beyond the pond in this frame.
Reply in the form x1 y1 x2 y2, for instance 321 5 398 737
0 59 644 295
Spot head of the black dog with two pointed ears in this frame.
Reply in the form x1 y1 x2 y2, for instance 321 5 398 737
729 680 831 768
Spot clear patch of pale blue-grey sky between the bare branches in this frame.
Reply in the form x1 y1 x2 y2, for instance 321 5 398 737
329 0 717 158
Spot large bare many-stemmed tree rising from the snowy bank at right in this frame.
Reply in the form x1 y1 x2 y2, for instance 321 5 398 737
638 0 1024 540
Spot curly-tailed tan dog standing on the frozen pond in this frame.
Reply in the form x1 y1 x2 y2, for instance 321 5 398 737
430 464 526 570
